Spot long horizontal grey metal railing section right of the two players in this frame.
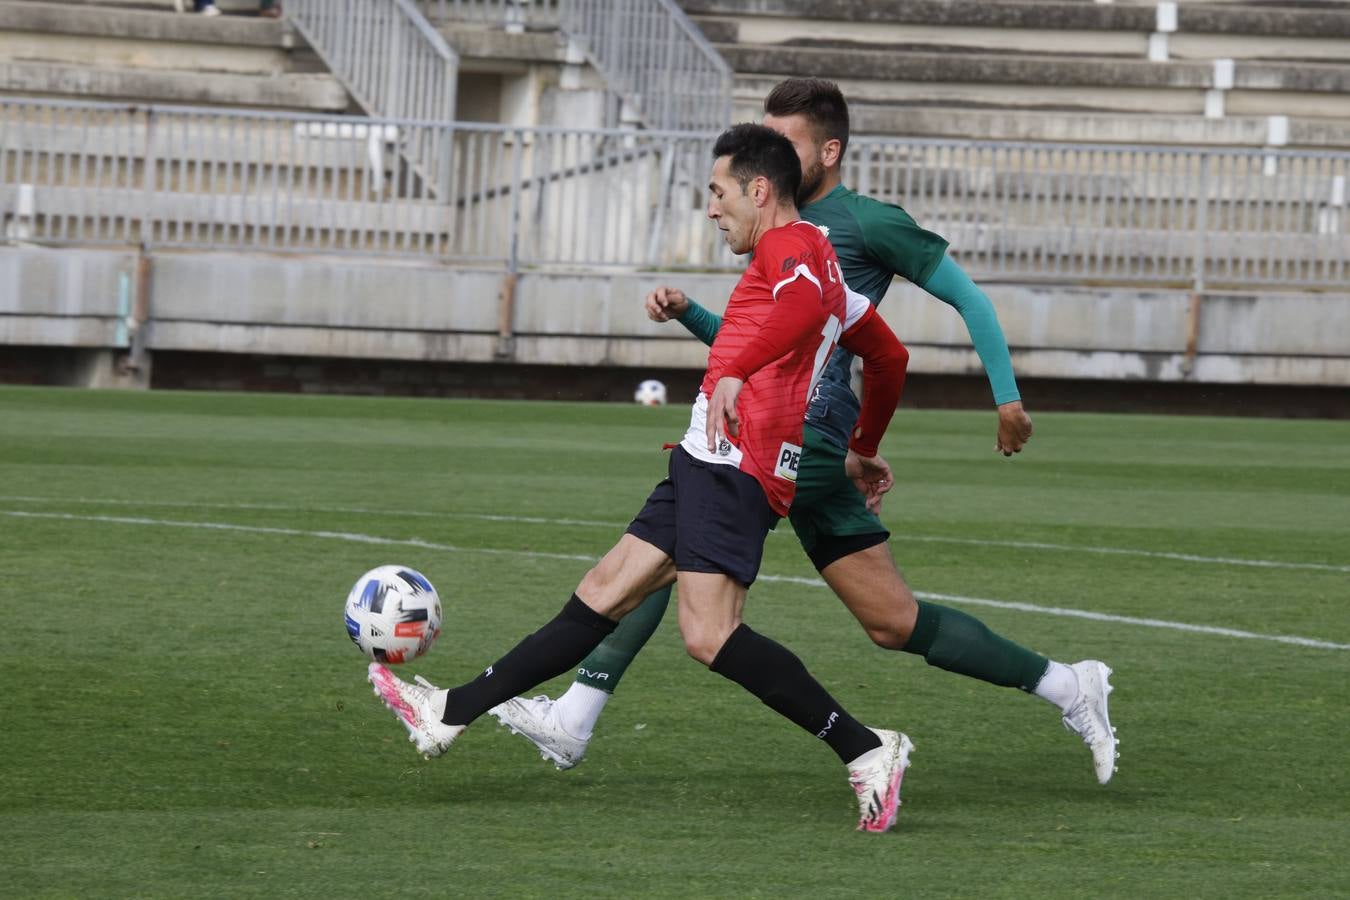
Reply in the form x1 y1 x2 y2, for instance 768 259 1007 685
844 138 1350 290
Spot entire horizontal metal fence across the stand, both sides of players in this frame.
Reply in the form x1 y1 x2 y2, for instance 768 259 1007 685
0 100 1350 289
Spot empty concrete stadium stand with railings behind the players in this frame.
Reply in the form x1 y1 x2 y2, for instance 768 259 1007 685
0 0 1350 402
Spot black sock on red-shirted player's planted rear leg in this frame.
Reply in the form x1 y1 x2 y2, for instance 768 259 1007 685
709 622 882 762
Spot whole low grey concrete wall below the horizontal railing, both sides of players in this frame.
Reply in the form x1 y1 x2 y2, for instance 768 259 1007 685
0 248 1350 387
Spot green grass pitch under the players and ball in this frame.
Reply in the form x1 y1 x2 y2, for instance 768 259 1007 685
0 389 1350 897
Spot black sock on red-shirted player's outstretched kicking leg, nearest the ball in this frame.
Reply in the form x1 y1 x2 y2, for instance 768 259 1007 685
440 594 617 725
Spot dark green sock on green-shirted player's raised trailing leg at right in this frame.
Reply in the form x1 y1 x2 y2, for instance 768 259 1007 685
901 600 1050 692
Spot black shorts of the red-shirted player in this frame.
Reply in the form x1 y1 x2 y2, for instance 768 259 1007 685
628 447 778 587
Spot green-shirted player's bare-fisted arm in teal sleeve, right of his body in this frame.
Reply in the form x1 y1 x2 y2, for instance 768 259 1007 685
919 256 1031 456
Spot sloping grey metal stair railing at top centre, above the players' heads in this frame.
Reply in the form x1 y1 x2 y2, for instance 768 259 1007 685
559 0 732 131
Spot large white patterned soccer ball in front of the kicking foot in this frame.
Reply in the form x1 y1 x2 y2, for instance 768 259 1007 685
343 565 440 663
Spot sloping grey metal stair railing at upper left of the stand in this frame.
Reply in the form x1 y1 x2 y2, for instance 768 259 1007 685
284 0 459 193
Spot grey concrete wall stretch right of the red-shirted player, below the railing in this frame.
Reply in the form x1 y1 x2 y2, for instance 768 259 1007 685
882 283 1350 386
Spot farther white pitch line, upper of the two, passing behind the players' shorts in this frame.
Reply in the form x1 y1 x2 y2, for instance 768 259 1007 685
0 495 1350 573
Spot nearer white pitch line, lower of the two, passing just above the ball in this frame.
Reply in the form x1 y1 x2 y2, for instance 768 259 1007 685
10 510 1350 650
